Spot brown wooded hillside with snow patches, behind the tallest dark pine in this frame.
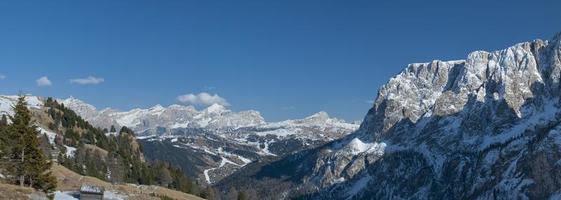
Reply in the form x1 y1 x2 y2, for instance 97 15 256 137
0 96 207 199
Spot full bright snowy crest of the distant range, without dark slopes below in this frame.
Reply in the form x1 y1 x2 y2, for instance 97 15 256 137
59 97 358 143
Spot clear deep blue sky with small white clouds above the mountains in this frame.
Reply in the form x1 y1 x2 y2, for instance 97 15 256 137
0 0 561 121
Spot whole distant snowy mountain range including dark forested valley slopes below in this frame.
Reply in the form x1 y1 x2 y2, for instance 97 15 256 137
59 97 359 184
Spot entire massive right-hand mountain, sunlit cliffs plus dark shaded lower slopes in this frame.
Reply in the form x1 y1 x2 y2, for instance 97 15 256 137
219 34 561 199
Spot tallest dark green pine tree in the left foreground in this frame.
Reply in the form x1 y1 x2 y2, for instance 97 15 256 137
8 96 56 192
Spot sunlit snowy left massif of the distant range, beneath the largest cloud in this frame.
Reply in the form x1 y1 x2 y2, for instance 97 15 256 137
60 97 265 136
